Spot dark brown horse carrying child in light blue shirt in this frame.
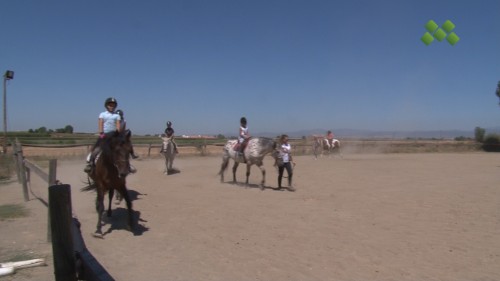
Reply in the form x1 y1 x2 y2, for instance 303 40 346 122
82 131 133 238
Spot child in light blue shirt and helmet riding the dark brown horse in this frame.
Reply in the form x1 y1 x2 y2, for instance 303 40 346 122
84 97 121 173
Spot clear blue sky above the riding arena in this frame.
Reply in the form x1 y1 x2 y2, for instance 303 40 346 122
0 0 500 134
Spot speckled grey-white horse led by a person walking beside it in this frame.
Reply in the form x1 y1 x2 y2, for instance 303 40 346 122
219 137 276 189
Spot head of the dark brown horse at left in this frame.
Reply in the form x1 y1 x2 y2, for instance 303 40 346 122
108 130 132 177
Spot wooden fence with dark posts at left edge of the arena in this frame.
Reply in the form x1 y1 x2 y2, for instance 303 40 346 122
13 140 114 281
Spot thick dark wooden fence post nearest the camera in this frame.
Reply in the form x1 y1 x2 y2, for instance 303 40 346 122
49 184 76 281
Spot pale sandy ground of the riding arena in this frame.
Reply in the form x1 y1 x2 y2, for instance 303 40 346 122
0 153 500 281
